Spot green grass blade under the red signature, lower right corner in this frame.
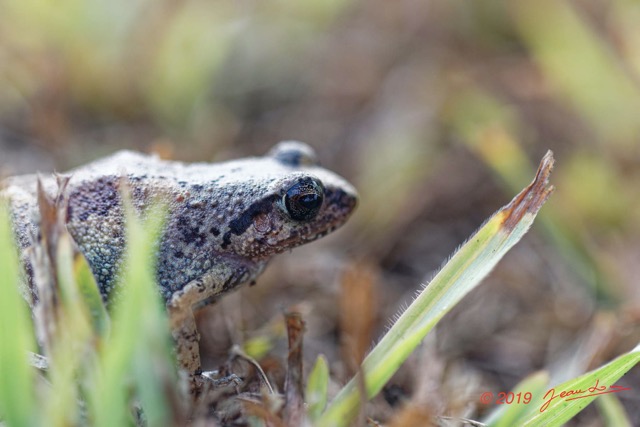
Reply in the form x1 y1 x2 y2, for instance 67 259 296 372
518 344 640 427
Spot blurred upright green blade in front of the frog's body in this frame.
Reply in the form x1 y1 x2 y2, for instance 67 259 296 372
91 200 177 427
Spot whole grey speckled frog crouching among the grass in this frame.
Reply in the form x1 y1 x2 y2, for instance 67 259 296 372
2 141 358 388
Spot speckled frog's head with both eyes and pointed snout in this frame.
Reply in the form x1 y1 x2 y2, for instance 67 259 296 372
222 141 357 259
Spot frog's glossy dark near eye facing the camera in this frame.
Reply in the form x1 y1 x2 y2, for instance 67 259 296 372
283 177 324 221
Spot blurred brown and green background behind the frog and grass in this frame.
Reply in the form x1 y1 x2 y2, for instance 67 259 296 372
0 0 640 426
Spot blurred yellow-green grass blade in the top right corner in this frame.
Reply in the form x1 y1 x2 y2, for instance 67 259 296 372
513 0 640 147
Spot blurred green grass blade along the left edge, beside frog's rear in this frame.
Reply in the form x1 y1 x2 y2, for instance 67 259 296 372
0 200 37 426
